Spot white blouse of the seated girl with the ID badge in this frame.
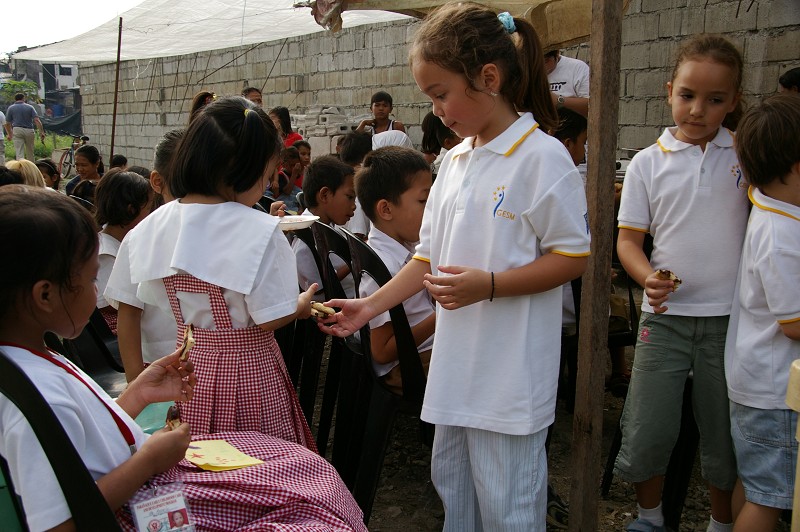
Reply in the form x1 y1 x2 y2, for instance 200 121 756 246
0 346 147 530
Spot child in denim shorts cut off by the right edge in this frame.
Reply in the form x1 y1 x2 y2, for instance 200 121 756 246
725 93 800 532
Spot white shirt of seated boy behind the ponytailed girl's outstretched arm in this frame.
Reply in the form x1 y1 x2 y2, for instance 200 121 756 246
358 225 436 377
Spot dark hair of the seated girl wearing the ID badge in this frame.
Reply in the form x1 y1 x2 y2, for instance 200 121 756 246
0 185 97 319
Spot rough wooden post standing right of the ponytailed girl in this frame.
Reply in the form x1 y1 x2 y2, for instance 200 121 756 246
569 0 622 532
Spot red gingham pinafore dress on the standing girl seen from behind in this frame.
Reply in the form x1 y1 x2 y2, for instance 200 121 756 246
164 274 317 451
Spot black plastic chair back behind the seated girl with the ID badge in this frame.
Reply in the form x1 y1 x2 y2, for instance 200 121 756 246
0 349 120 530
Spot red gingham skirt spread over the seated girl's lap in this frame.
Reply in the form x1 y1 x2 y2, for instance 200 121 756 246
117 432 367 532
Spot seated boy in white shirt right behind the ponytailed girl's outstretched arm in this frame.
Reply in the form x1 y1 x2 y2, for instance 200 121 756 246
356 148 436 394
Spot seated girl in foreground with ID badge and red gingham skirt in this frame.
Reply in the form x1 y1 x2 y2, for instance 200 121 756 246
0 185 366 532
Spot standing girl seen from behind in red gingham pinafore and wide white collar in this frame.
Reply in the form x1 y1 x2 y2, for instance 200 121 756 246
113 97 315 449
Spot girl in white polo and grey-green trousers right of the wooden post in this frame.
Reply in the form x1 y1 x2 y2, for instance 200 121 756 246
615 35 748 532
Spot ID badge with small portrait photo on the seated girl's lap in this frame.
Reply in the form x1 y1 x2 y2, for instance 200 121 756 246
130 482 194 532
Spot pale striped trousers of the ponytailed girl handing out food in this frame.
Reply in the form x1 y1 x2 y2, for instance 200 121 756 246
431 425 547 532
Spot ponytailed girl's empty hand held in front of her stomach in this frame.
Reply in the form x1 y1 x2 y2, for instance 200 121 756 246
423 266 494 310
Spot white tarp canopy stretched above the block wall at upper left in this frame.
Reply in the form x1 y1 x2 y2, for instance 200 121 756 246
13 0 408 62
